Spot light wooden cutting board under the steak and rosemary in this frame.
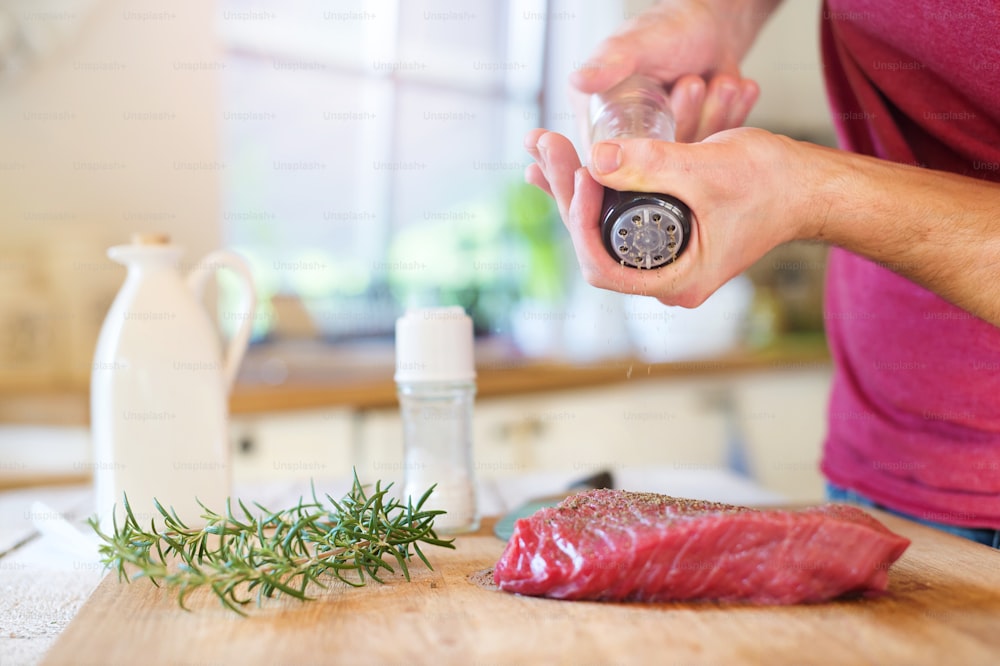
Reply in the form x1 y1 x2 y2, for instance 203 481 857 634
43 513 1000 666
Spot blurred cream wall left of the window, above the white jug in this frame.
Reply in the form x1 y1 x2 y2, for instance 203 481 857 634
0 0 225 385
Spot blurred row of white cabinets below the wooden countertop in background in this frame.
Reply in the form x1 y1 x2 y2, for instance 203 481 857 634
232 364 830 501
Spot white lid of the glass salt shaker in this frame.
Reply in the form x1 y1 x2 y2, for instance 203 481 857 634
395 306 476 382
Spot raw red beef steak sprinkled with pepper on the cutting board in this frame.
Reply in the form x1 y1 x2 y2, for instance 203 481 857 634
493 490 910 604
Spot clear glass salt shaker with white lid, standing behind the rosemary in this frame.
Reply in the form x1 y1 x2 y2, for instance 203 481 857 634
395 307 479 534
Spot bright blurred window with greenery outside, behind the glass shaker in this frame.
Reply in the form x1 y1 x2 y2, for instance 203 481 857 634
219 0 557 339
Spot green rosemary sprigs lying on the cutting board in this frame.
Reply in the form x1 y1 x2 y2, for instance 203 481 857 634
88 472 455 615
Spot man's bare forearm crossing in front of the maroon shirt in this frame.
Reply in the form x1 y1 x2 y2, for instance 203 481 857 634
801 144 1000 326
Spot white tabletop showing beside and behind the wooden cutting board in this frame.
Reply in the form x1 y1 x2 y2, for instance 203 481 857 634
0 468 781 666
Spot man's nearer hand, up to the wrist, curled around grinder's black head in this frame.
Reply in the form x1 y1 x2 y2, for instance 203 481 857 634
525 129 813 307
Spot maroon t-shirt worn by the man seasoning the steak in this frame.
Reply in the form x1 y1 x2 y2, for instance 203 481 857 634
822 0 1000 529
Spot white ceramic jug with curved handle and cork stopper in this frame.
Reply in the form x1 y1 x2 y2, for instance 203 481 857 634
90 235 256 532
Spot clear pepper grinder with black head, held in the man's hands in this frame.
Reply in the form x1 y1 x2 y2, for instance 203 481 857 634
590 74 691 269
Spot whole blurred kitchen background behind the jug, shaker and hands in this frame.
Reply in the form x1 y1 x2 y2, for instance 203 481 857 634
0 0 833 500
